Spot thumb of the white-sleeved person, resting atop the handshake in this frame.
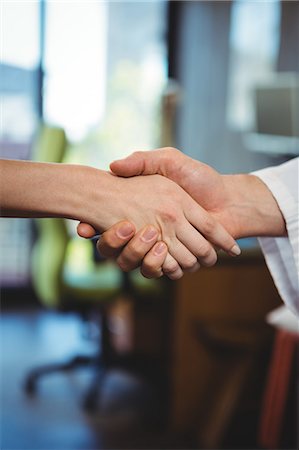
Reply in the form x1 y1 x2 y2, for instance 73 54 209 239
110 149 169 177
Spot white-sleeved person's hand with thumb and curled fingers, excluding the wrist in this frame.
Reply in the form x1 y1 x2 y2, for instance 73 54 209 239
78 148 240 270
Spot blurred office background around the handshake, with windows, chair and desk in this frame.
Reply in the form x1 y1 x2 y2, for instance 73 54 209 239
0 0 299 450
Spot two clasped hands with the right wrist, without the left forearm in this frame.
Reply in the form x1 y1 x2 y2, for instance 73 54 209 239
77 148 286 279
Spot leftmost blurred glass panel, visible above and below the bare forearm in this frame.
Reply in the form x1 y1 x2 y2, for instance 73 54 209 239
0 1 40 286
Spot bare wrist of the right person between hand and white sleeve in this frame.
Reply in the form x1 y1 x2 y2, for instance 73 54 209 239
223 174 287 238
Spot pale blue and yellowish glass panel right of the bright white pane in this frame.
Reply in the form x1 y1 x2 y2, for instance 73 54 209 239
96 2 167 166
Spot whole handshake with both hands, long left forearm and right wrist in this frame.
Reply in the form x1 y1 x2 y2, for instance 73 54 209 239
0 148 288 280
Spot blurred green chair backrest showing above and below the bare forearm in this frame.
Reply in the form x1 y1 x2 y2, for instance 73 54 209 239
31 125 69 308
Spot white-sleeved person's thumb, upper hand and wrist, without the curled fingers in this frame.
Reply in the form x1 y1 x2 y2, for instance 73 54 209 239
110 148 286 239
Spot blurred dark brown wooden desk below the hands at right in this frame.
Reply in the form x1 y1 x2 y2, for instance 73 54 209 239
171 249 281 448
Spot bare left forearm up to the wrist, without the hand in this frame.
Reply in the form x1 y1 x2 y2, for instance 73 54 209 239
0 160 112 229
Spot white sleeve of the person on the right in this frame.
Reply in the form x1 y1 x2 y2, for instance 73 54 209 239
252 158 299 315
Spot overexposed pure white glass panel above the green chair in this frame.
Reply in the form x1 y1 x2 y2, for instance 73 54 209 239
44 2 107 140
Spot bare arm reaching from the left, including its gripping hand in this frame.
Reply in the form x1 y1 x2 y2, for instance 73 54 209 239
0 161 239 278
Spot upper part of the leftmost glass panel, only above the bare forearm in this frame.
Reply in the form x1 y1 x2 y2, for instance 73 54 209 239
0 2 40 147
